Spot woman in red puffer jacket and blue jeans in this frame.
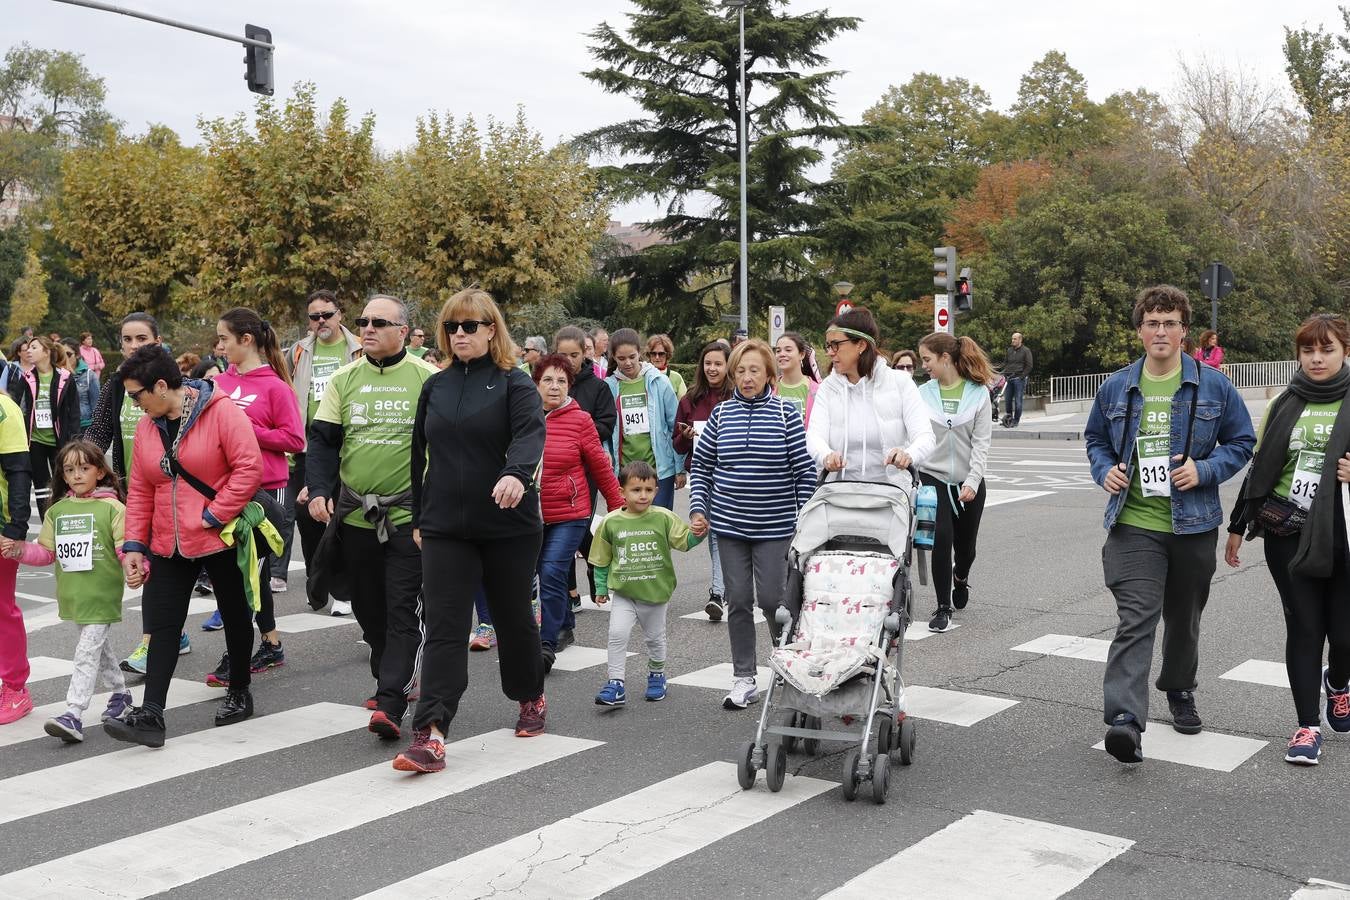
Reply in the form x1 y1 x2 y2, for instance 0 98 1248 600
533 354 624 672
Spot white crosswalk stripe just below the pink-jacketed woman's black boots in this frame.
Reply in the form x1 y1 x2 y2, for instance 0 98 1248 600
0 703 370 824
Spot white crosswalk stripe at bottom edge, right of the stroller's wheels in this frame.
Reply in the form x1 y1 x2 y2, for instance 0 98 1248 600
822 810 1134 900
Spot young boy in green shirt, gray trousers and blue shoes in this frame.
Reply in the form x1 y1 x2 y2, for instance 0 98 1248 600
590 460 701 706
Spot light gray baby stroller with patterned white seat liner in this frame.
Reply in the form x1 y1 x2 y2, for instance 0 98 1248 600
737 470 919 803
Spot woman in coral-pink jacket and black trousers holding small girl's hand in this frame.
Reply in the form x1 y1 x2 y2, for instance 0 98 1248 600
105 344 262 746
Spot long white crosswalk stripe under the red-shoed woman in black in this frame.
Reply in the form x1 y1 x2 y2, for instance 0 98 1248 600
0 729 602 900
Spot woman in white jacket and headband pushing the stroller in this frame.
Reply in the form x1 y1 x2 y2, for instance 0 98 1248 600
806 306 934 493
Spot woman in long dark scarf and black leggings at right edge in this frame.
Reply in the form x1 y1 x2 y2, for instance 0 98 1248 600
1223 316 1350 765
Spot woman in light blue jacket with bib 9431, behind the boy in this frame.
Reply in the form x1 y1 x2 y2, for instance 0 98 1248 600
605 328 684 509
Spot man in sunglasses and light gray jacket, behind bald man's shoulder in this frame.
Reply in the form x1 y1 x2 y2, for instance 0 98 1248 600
282 290 360 615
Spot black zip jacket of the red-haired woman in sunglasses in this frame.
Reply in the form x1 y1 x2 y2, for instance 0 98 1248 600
412 355 542 539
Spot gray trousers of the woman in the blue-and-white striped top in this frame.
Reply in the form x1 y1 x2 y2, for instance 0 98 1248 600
717 534 792 679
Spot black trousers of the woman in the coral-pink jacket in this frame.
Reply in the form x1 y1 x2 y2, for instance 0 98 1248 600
140 546 252 710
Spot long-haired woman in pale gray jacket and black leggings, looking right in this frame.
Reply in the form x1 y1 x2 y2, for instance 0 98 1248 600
919 332 994 631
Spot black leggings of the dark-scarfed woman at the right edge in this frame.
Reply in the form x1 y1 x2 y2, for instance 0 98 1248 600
1265 515 1350 727
